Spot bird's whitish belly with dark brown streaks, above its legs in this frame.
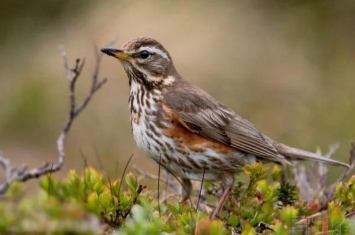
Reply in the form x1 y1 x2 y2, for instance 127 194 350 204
132 118 255 181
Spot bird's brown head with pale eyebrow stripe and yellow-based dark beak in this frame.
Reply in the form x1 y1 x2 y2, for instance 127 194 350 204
101 38 179 88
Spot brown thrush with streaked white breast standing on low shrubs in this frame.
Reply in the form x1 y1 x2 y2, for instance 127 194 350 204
101 37 349 219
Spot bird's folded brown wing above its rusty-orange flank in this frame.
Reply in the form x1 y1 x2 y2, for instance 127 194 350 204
164 81 288 164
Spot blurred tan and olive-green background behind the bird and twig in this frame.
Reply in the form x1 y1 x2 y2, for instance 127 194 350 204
0 0 355 190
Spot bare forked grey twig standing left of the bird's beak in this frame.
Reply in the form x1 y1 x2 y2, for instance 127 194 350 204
0 43 107 195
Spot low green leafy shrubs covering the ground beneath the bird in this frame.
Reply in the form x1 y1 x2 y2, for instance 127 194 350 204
0 163 355 235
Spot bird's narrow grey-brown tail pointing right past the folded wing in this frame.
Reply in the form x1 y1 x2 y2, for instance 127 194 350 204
273 141 350 169
